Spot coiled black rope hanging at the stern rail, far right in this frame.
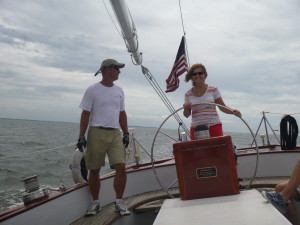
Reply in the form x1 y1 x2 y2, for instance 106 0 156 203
280 115 298 150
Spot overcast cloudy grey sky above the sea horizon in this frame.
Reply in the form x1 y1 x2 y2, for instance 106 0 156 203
0 0 300 132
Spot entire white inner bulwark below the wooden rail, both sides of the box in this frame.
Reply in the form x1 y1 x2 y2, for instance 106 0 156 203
0 148 300 225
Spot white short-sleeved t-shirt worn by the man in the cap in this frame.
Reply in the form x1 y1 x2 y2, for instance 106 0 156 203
79 83 125 128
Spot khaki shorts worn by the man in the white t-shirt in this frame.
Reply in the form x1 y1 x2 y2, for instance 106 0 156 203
85 127 125 170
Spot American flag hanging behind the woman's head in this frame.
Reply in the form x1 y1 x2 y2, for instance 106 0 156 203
166 36 188 92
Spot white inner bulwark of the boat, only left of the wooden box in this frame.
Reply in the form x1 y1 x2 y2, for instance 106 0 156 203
0 161 176 225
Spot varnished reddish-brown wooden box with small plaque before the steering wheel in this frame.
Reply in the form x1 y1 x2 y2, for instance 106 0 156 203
173 136 240 200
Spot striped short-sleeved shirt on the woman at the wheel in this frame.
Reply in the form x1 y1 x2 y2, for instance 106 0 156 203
184 85 221 127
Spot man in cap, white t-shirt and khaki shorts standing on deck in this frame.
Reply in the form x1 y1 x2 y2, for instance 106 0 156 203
77 59 130 216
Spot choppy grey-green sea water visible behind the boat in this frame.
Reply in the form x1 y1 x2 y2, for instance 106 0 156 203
0 119 288 211
